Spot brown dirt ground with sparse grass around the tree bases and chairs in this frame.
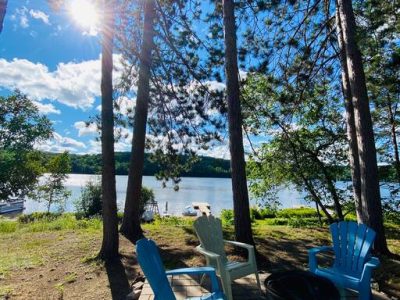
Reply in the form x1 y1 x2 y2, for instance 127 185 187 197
0 225 400 299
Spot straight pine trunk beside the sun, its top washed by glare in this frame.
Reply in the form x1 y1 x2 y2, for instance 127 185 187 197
99 0 119 260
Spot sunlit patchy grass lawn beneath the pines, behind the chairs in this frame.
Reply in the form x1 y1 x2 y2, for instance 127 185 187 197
0 215 400 299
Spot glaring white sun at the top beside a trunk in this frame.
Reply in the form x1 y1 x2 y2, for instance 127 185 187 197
69 0 100 33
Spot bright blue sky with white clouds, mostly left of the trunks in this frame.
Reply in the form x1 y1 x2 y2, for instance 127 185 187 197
0 0 264 158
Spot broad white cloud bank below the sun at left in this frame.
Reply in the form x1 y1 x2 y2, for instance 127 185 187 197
0 55 120 109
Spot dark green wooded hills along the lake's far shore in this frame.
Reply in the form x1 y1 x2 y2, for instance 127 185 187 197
43 152 397 182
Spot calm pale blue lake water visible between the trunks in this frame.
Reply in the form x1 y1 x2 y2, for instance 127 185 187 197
24 174 306 216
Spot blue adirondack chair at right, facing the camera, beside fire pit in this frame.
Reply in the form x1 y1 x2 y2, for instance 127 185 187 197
308 221 379 300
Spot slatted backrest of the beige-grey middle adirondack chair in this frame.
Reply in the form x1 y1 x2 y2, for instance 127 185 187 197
194 215 227 262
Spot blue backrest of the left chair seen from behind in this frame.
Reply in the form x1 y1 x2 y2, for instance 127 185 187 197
136 239 176 300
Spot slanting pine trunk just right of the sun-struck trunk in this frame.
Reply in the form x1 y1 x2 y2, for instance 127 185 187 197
121 0 155 243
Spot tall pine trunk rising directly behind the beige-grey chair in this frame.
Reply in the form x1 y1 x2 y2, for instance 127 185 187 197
223 0 254 244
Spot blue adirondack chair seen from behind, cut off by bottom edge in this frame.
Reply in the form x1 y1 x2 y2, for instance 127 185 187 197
136 239 225 300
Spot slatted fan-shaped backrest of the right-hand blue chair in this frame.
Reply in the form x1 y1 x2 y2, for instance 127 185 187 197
330 221 376 276
